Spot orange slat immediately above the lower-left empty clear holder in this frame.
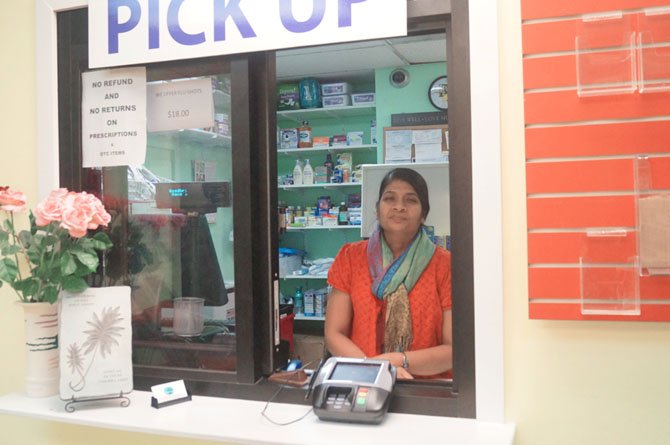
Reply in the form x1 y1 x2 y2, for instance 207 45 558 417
526 195 635 229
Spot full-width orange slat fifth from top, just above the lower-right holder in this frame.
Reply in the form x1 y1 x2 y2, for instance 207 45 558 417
526 120 670 159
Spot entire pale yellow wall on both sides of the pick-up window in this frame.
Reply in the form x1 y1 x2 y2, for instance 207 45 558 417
5 0 670 445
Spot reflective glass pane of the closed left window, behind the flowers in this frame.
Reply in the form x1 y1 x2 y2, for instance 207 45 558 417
98 73 237 372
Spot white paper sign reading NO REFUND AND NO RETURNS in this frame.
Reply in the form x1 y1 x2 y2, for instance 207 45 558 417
81 67 147 167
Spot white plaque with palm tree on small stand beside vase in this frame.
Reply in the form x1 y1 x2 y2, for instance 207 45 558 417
59 286 133 400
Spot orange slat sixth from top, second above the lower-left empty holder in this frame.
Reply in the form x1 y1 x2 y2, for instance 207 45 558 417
526 159 635 194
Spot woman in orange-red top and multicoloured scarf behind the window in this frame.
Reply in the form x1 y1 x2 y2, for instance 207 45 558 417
325 168 452 379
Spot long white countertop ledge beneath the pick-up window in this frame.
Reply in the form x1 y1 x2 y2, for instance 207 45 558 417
0 391 514 445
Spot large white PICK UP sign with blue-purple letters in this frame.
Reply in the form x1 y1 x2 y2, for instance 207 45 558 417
88 0 407 67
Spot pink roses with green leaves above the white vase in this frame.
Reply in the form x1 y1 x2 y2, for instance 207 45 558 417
0 187 112 303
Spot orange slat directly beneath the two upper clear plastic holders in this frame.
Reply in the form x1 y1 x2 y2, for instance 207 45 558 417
524 90 670 125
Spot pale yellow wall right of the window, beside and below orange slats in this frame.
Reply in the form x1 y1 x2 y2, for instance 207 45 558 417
499 0 670 445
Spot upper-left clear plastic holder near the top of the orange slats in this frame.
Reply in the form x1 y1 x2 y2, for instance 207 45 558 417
575 11 637 97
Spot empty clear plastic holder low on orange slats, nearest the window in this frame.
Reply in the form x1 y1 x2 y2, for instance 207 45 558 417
579 229 640 316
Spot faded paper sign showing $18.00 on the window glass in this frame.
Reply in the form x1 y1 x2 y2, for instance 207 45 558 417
147 78 214 132
